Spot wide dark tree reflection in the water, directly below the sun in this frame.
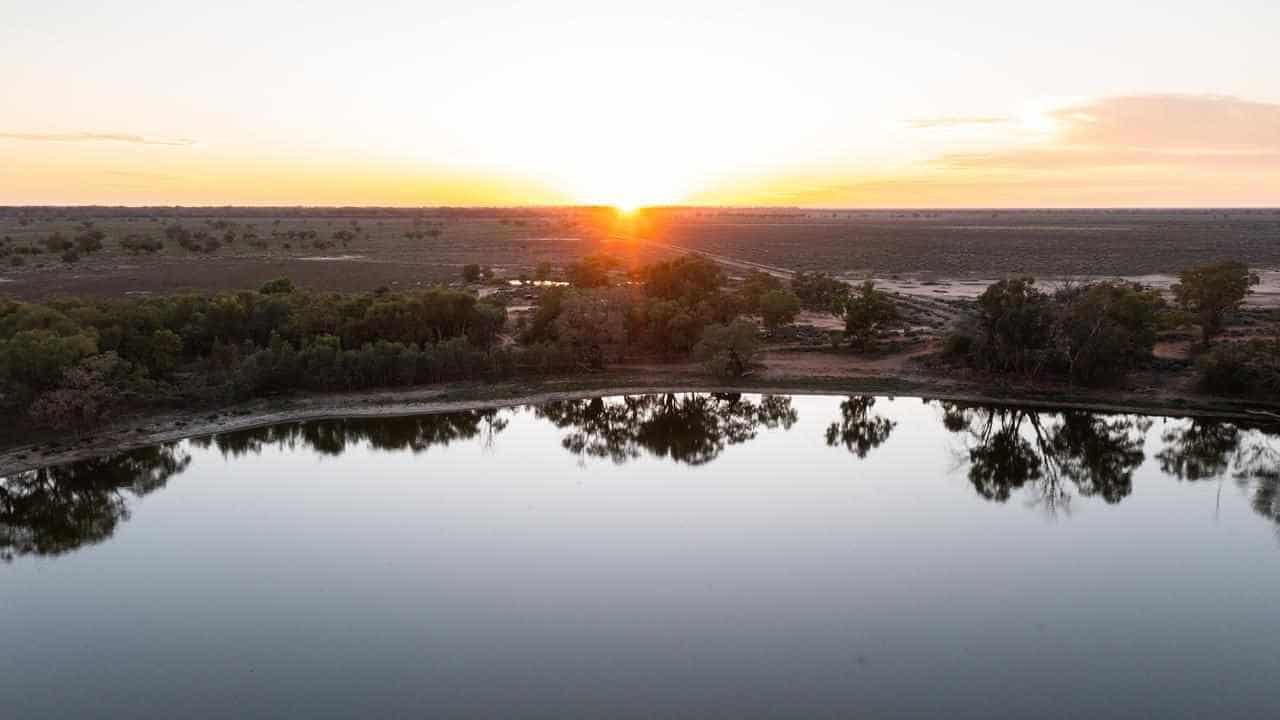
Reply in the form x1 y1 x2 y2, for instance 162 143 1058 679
535 393 796 465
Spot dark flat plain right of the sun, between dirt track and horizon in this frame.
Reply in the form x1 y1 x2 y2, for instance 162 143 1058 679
644 209 1280 281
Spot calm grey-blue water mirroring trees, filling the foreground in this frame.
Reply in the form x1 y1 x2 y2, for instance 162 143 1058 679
0 395 1280 719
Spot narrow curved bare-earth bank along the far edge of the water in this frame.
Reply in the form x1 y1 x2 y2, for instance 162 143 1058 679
0 353 1280 477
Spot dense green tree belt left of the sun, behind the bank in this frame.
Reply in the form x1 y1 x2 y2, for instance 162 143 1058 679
0 279 514 427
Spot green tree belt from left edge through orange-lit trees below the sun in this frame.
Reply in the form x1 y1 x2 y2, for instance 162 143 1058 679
0 253 773 428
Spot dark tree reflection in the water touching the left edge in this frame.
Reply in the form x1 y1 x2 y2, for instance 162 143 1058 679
0 443 191 561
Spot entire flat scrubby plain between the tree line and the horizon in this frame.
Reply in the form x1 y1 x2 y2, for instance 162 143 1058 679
0 208 1280 299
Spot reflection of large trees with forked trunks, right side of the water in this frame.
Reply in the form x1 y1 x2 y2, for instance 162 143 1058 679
941 402 1151 512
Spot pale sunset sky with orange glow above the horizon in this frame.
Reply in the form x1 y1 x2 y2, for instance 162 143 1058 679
0 0 1280 208
